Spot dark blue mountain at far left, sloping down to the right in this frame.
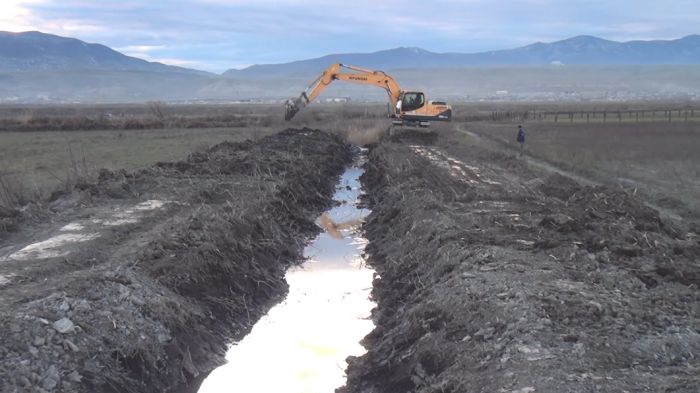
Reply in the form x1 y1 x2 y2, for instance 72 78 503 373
0 31 211 75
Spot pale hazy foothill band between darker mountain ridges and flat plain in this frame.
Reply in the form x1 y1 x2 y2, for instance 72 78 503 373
0 66 700 102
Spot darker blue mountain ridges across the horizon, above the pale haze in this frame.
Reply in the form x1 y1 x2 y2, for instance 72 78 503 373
0 31 700 77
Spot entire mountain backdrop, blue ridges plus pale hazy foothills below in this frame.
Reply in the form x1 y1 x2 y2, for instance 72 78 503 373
0 32 700 103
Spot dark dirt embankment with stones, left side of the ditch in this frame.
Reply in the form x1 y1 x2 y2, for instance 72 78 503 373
0 129 353 392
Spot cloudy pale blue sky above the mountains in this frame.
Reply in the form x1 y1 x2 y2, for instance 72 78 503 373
0 0 700 73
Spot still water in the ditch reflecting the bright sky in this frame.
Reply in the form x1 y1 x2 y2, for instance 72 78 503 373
199 160 375 393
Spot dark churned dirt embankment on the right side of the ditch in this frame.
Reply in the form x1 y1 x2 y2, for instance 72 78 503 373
337 136 700 393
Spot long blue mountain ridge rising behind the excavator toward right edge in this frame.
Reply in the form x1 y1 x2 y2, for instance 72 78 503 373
224 35 700 76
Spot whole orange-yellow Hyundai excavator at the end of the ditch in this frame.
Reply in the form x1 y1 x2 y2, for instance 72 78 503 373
284 63 452 134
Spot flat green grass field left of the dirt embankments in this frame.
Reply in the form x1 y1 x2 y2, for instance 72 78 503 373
0 128 272 205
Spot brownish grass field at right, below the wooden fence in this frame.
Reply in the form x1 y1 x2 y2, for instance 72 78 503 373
468 122 700 218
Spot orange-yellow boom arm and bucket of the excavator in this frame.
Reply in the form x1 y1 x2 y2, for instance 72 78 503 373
284 63 401 120
